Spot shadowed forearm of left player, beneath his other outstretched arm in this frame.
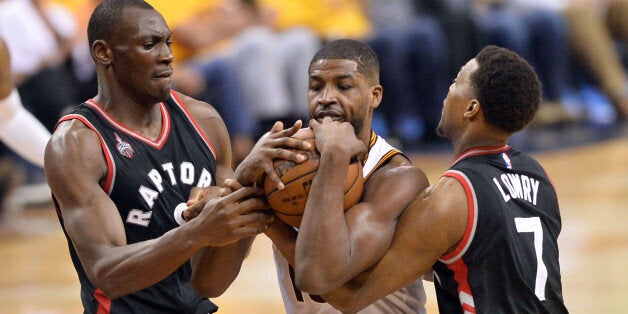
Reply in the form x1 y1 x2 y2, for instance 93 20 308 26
192 237 255 298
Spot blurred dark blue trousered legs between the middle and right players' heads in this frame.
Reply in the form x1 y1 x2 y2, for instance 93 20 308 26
364 0 457 150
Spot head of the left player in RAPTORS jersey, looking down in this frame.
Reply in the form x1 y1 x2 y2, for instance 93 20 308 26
87 0 174 103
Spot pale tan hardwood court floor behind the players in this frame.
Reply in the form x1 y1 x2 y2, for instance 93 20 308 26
0 136 628 314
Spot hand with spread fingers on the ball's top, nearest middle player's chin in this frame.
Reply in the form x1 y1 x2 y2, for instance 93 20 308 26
234 120 312 190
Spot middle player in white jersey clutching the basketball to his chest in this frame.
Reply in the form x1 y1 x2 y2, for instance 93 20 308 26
236 40 428 313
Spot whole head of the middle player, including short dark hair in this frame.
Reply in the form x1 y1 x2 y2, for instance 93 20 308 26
307 39 382 134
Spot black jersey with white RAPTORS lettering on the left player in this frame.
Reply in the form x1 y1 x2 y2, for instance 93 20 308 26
54 92 221 313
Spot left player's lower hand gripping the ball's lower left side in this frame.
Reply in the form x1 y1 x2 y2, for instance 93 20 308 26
194 187 274 246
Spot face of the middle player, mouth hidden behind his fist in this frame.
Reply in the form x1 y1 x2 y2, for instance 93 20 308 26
307 59 382 134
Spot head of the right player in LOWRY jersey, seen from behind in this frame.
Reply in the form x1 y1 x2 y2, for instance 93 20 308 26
437 46 541 138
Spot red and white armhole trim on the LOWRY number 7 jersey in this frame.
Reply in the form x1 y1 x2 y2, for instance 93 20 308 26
440 170 478 264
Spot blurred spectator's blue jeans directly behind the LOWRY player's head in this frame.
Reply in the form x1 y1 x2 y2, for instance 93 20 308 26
472 0 578 125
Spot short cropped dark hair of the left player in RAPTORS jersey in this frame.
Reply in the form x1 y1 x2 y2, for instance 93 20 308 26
87 0 154 47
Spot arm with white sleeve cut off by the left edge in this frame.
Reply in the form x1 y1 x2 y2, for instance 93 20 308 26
0 37 50 167
